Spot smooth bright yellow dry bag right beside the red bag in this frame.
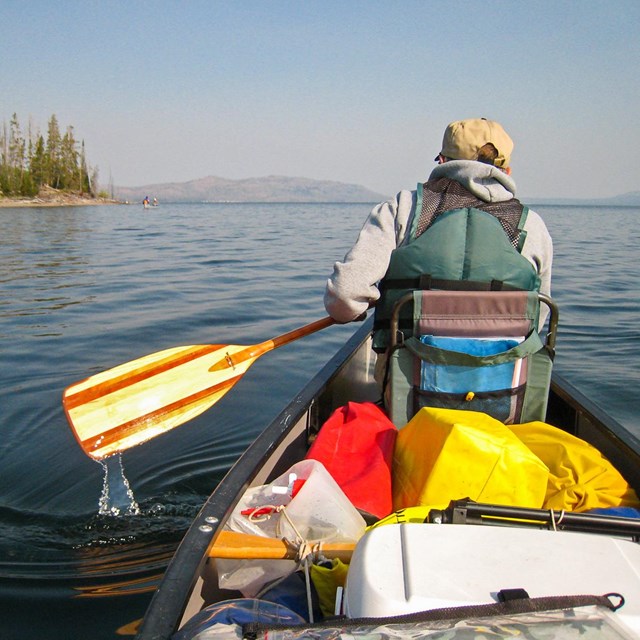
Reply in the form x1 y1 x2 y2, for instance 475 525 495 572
393 407 549 510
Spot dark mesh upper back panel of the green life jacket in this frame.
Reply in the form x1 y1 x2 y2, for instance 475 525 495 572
415 178 522 248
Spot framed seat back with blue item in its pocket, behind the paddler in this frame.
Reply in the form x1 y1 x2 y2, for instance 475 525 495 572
385 289 558 428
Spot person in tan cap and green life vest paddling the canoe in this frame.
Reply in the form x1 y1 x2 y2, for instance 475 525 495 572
324 118 553 380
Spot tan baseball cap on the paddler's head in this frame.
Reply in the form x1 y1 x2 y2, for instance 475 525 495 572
440 118 513 168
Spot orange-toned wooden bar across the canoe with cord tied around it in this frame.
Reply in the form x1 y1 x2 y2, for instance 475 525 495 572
209 530 355 562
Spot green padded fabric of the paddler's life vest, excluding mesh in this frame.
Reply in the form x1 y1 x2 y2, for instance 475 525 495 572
373 198 540 352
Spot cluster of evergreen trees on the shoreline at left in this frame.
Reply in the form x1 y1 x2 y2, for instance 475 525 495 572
0 113 98 199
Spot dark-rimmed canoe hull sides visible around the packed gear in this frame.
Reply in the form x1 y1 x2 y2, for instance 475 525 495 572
138 321 640 640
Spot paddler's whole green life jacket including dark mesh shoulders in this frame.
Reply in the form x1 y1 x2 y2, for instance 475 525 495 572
373 178 540 353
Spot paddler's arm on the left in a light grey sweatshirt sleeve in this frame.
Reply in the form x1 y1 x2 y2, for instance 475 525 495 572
324 192 411 322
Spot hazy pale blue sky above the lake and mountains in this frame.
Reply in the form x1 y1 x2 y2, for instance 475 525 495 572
0 0 640 198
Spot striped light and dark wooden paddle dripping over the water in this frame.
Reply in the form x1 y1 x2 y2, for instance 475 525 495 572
62 316 335 460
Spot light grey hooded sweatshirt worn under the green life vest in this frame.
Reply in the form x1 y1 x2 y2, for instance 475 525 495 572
324 160 553 326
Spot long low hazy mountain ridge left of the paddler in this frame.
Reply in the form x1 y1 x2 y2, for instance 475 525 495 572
113 176 387 202
